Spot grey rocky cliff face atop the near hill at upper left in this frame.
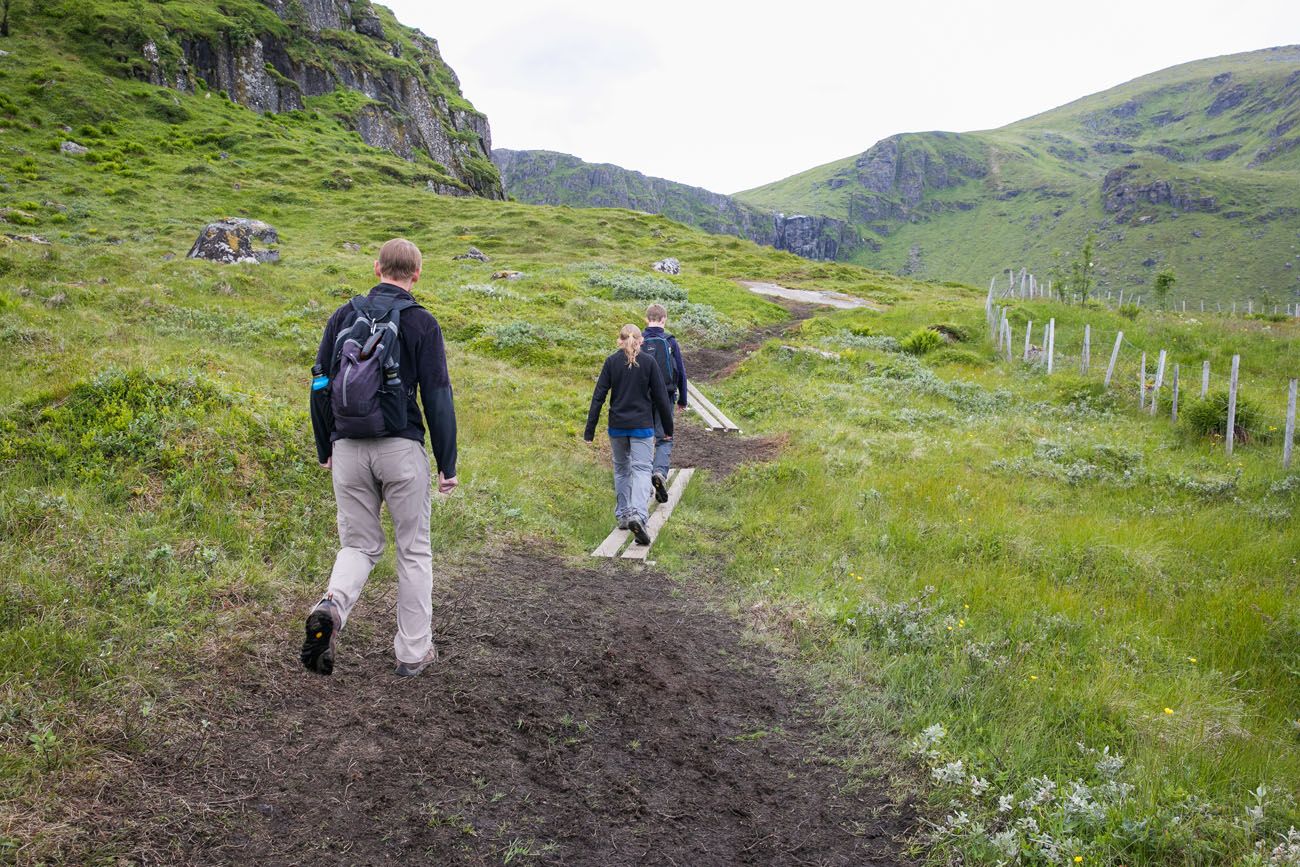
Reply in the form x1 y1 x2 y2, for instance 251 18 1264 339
133 0 503 199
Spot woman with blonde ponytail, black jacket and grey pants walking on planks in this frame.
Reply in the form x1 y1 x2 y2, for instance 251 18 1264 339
582 325 672 545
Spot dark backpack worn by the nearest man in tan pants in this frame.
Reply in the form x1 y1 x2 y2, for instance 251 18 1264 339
329 295 419 439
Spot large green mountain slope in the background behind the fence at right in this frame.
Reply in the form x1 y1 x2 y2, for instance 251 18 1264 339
736 45 1300 303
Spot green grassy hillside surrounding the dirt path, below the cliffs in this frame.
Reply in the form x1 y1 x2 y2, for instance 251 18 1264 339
0 20 1300 864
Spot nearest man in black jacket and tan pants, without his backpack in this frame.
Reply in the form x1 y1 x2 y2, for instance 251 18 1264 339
302 238 456 677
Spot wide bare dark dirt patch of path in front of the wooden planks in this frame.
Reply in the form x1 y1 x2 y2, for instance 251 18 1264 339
86 550 910 867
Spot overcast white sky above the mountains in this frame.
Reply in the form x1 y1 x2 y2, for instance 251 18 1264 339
380 0 1300 192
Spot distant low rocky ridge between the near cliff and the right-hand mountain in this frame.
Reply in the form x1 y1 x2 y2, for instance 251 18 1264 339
493 148 863 259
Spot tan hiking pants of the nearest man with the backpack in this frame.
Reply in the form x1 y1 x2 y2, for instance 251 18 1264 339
328 437 433 663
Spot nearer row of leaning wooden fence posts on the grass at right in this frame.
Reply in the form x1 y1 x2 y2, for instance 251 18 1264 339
984 269 1300 469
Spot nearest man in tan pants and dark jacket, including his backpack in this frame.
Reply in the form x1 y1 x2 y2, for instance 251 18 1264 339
302 238 456 677
